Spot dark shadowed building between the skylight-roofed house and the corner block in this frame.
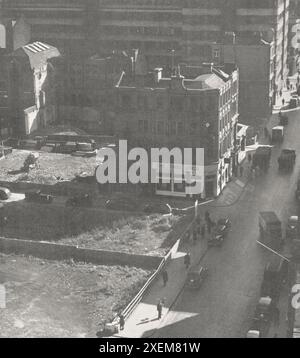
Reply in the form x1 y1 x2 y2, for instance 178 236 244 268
50 50 143 134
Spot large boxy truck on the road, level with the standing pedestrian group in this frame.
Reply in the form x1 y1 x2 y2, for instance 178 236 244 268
258 211 284 251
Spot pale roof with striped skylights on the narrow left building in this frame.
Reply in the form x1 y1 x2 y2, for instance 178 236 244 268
12 41 60 68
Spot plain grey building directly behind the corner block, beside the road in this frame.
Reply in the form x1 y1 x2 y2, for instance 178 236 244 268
212 33 278 128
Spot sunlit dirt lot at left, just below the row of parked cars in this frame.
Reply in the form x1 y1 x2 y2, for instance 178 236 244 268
0 149 97 185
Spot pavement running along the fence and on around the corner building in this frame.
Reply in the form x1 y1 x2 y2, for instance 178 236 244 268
114 166 254 338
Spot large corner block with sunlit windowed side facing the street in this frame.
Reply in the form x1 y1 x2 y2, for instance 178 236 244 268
113 64 238 198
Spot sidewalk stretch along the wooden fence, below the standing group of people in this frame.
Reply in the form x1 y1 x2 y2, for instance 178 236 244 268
113 234 207 338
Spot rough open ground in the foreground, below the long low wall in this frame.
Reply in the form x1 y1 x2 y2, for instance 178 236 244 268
0 254 151 337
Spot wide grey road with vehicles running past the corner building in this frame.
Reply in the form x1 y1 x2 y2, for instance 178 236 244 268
156 111 300 338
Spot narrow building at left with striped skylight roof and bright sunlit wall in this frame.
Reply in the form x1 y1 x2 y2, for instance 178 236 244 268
6 42 60 136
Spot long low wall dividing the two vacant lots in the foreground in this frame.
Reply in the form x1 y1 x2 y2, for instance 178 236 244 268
0 237 162 270
